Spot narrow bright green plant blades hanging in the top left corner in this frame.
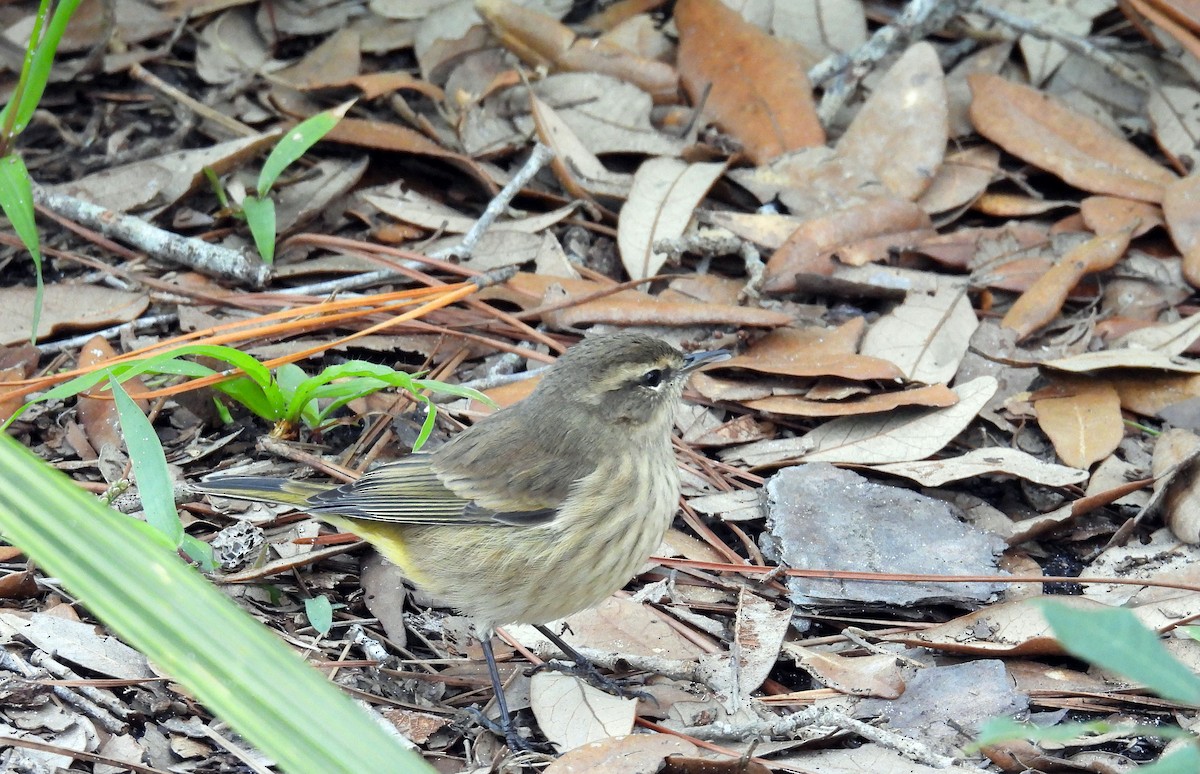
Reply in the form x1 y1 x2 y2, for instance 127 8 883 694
0 0 82 341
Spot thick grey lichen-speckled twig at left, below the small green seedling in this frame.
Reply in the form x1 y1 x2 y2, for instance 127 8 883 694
34 186 271 288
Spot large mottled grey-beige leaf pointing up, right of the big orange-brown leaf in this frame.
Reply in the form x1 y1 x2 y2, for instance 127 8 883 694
838 42 949 202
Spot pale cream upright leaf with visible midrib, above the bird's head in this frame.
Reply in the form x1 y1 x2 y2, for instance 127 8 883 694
617 157 725 280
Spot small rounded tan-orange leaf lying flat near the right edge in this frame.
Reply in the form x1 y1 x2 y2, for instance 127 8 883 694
1033 377 1124 468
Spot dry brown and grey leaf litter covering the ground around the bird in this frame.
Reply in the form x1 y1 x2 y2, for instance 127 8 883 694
0 0 1200 772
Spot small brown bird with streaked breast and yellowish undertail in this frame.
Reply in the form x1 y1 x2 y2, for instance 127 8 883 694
196 332 730 748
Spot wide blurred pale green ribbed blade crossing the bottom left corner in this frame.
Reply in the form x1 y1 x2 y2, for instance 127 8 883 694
0 434 433 774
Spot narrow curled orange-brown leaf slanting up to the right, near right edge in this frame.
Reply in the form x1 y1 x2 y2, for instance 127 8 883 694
1001 226 1129 341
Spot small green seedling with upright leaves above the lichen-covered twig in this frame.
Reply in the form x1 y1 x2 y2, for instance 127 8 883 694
204 101 354 263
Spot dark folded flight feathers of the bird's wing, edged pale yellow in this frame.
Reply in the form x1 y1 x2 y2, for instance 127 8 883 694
301 454 557 526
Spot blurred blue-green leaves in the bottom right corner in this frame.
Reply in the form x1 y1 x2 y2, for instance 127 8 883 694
976 601 1200 774
